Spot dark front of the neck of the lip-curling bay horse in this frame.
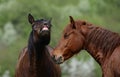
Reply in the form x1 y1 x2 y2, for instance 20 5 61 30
28 32 49 77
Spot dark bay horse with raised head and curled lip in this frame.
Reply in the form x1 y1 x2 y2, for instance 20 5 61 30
15 14 61 77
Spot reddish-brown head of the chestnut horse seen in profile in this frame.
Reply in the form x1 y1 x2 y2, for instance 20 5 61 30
52 16 87 64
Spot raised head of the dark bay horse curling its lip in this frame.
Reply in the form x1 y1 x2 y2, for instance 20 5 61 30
28 14 51 45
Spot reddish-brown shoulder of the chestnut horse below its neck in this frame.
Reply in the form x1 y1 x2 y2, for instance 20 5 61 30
102 46 120 77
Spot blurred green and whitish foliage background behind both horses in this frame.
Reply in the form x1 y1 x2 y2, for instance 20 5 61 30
0 0 120 77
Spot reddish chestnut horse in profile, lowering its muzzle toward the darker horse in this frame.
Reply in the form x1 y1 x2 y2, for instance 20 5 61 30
52 16 120 77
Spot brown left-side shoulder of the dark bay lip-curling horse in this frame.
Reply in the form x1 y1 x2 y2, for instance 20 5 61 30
15 47 29 77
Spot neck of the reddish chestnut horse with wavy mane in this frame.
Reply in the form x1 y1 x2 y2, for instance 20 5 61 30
84 27 120 65
